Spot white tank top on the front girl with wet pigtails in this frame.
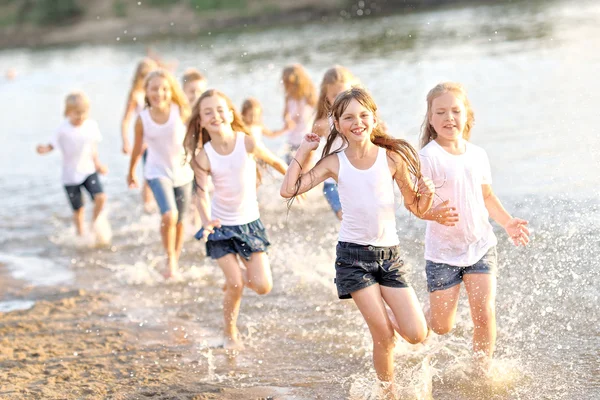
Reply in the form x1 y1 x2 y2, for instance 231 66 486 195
337 148 400 247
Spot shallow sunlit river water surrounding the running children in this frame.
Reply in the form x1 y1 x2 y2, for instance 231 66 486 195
0 1 600 399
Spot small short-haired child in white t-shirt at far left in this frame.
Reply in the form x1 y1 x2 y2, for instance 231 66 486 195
37 92 108 236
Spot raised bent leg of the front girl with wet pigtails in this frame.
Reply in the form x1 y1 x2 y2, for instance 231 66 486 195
381 286 427 344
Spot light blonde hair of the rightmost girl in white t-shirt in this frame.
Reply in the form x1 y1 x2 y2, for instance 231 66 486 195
419 82 475 148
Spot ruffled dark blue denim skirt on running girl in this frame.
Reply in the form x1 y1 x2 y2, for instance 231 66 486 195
195 218 271 260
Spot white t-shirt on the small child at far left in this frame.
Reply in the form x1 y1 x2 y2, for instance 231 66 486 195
50 119 102 186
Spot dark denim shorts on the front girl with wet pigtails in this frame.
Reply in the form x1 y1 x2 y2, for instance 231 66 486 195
335 242 410 299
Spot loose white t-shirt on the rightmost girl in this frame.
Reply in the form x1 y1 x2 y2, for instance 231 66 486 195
419 140 497 267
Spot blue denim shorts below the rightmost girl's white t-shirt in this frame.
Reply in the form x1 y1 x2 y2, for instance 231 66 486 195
425 246 498 293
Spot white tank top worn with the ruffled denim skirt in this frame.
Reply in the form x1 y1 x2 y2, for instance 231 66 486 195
204 132 260 225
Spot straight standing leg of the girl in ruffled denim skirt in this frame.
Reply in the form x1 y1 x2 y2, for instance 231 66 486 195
217 254 244 349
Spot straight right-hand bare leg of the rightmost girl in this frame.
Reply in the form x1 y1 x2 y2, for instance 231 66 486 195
463 274 496 367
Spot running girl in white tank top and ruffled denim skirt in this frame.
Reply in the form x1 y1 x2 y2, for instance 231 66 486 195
185 90 286 349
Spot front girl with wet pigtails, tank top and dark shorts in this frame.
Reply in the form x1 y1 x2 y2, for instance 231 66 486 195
281 88 434 393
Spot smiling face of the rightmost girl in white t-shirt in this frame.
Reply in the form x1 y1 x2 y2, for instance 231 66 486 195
429 92 467 141
